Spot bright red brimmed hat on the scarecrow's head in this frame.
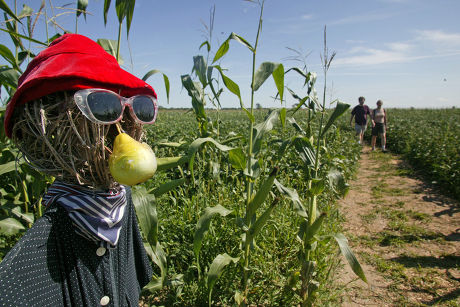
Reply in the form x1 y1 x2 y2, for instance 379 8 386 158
5 34 157 138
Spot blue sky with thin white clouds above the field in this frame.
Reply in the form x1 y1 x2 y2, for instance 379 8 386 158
0 0 460 108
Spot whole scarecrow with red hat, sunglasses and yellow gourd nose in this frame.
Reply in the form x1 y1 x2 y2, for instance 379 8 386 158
0 34 158 306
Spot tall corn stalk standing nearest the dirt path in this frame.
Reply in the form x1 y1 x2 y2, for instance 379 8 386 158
276 28 366 306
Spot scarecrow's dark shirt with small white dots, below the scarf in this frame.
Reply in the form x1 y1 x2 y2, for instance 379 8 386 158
0 188 152 307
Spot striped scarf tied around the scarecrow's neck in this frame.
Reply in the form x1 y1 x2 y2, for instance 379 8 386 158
42 181 127 247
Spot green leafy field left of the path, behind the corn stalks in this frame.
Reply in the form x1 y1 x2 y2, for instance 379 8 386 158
137 110 360 306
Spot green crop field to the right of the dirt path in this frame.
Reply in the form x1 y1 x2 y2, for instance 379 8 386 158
368 108 460 199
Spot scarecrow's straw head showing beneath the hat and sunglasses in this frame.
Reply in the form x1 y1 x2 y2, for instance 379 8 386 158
12 92 143 189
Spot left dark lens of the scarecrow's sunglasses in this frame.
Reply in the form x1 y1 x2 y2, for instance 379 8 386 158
87 92 122 122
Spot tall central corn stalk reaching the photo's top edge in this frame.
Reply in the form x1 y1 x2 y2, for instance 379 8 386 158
181 2 304 305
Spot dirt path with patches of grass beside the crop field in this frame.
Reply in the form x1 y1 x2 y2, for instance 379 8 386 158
339 147 460 306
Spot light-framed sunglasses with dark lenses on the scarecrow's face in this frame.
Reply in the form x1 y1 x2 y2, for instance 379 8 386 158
74 88 158 125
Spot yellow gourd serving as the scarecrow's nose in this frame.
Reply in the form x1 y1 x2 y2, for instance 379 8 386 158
109 133 157 186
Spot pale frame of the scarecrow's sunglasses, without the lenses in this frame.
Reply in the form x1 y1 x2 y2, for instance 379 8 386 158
74 88 158 125
